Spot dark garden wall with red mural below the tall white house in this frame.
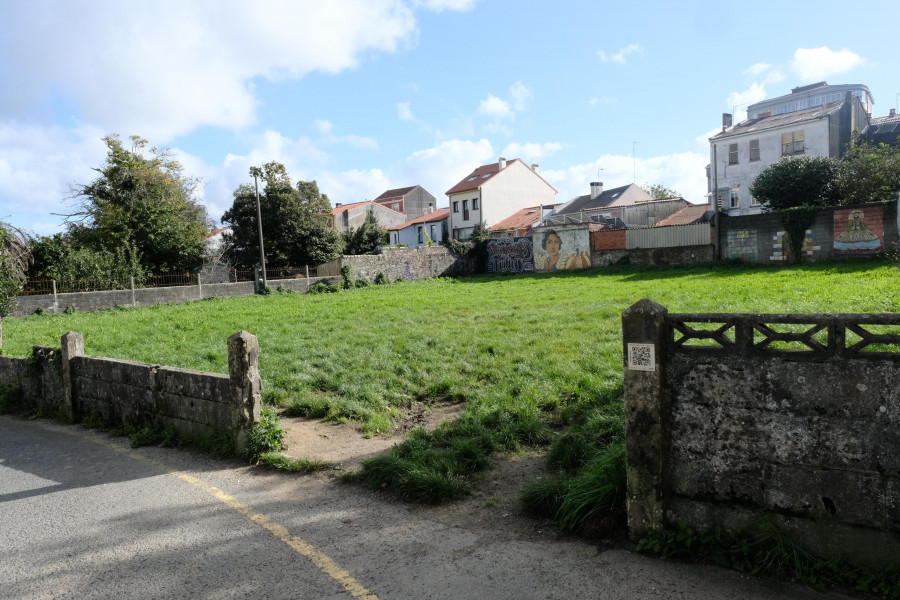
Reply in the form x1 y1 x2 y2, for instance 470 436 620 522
719 202 900 264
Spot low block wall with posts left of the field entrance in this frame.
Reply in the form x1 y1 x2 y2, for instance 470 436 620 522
0 331 261 453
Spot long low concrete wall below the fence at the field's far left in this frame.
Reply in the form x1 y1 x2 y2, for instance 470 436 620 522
13 277 339 317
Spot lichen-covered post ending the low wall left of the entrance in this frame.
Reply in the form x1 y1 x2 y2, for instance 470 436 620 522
228 331 262 454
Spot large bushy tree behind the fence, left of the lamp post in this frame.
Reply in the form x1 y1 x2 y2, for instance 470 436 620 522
67 135 210 272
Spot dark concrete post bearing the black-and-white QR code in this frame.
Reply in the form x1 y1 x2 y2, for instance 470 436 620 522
622 298 669 538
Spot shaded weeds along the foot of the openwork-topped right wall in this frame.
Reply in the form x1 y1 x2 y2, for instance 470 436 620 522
637 518 900 598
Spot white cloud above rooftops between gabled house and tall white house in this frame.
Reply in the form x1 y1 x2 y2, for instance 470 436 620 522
541 152 709 204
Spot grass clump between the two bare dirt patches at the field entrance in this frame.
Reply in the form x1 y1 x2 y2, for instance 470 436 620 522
352 409 548 504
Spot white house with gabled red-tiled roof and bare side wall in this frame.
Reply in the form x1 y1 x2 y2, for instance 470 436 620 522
447 156 556 240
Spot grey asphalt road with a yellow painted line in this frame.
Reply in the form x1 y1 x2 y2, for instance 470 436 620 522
0 416 847 600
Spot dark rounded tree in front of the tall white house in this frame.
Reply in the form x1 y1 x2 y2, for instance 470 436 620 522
750 156 840 211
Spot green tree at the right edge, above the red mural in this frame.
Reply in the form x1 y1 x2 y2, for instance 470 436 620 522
838 139 900 204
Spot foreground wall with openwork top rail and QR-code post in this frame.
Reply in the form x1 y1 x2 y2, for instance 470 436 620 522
622 299 900 566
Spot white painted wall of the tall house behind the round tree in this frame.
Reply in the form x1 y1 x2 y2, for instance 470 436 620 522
709 118 829 216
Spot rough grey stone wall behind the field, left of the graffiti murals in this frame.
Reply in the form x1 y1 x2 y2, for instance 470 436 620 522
316 246 474 281
